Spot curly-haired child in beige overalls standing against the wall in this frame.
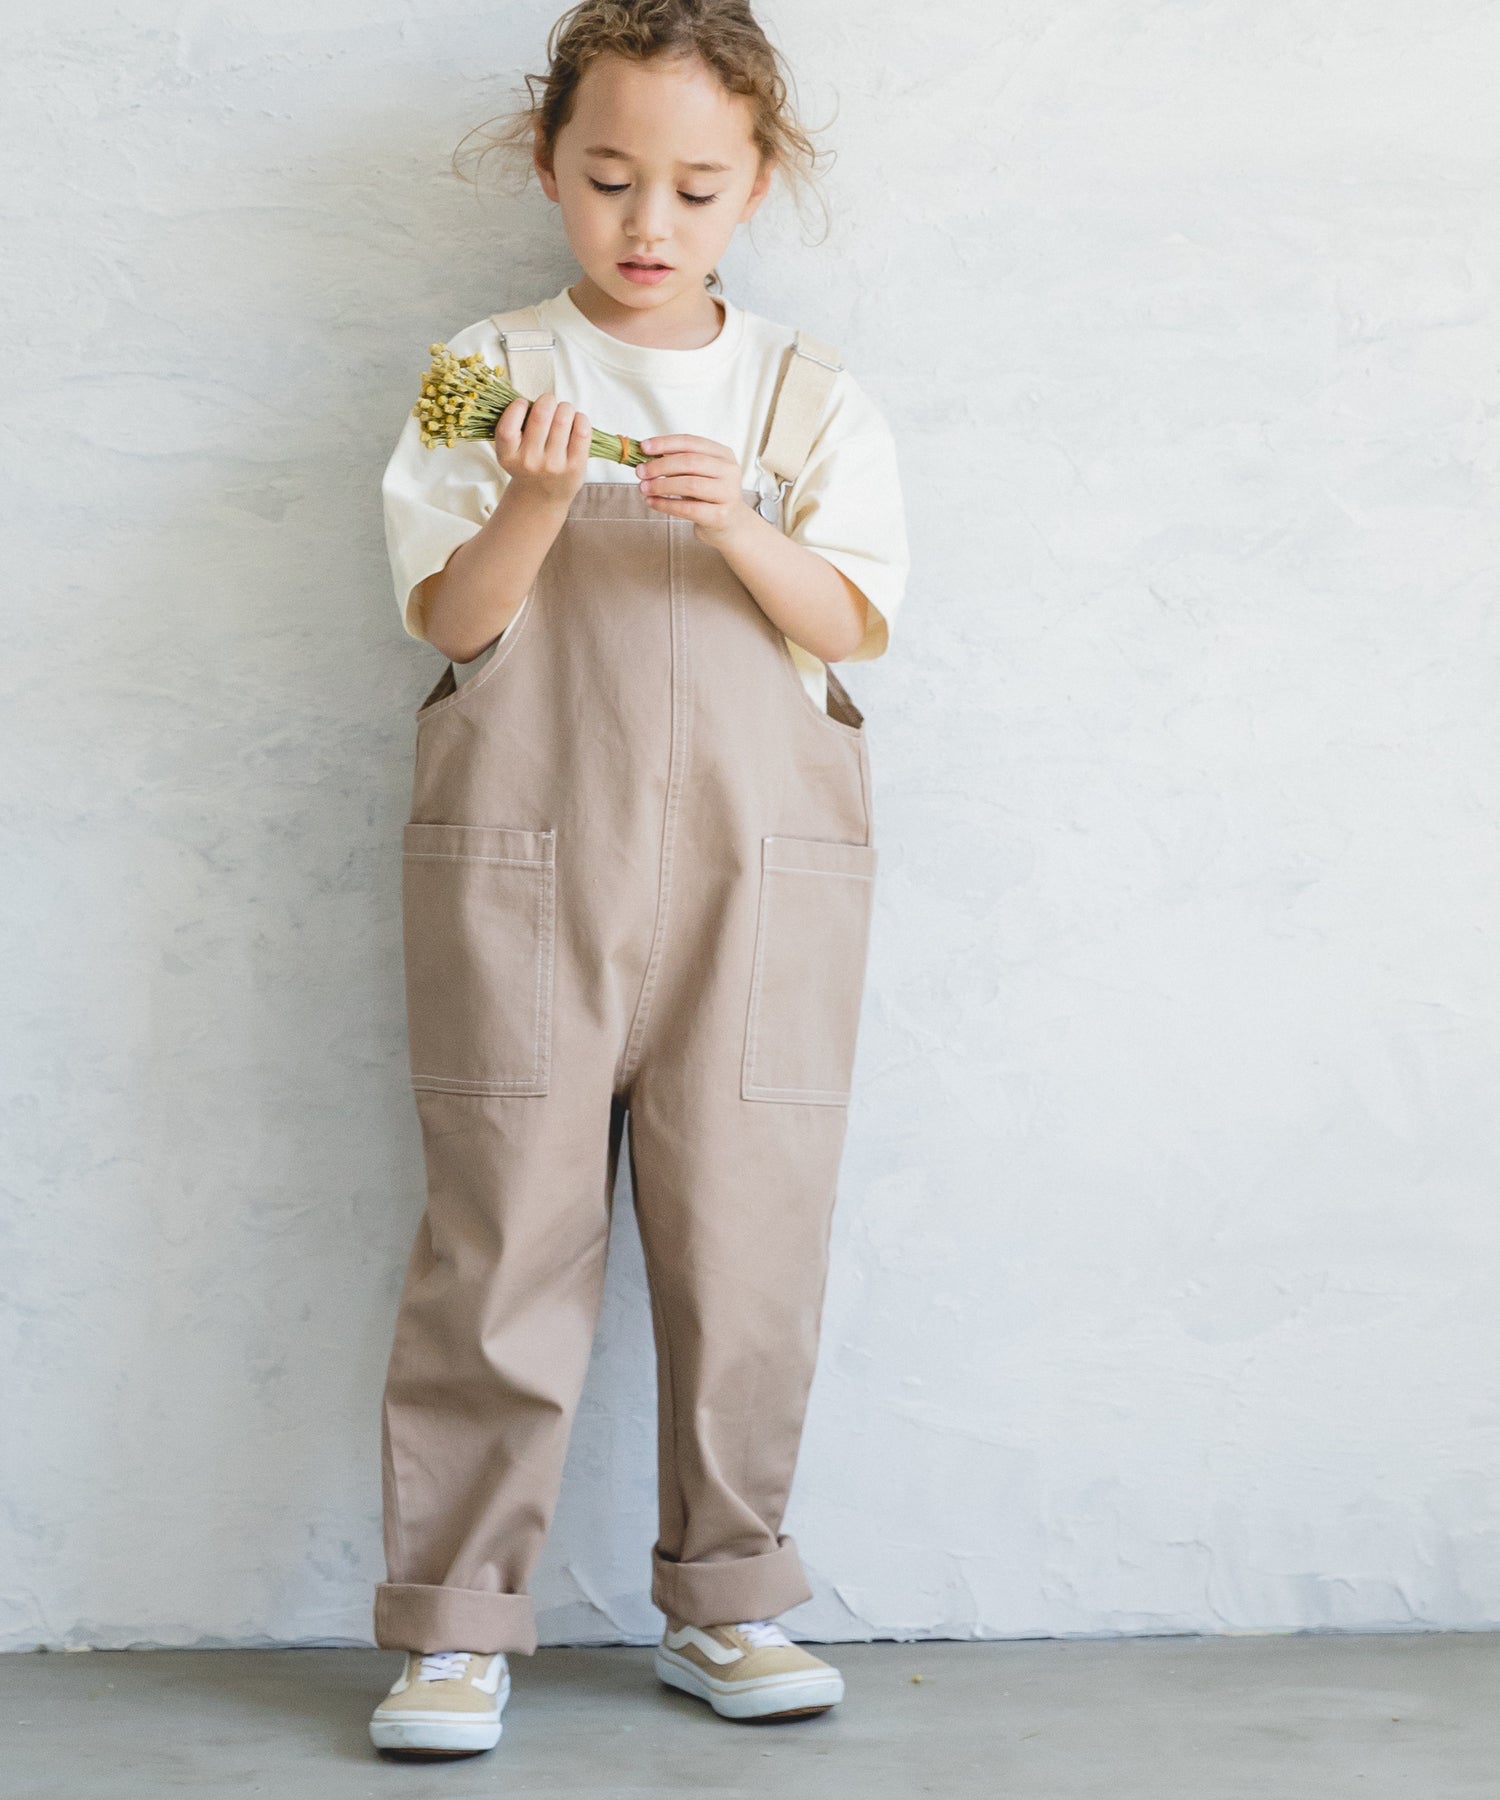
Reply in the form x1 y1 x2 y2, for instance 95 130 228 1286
371 0 908 1753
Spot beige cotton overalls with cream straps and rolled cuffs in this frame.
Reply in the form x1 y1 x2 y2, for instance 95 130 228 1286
375 308 877 1652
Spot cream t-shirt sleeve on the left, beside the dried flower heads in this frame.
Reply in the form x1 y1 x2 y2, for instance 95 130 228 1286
380 320 510 641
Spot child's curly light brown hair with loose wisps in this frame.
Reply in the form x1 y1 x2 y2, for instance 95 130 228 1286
452 0 837 288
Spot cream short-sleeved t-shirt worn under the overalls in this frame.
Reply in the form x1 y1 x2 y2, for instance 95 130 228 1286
380 286 909 709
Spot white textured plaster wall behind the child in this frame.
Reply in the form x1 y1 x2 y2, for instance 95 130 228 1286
0 0 1500 1649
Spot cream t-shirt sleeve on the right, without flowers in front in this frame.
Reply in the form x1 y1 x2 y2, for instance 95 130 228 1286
785 369 911 662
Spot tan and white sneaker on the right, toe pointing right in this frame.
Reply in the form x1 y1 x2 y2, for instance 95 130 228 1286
655 1618 845 1719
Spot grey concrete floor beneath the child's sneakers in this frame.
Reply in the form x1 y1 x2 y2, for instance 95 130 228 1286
0 1633 1500 1800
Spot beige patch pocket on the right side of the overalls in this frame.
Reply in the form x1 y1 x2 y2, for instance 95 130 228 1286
740 837 877 1107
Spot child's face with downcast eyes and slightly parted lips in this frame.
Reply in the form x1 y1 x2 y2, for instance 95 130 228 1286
535 56 771 317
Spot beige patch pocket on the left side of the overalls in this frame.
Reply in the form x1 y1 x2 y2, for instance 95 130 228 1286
402 824 556 1094
